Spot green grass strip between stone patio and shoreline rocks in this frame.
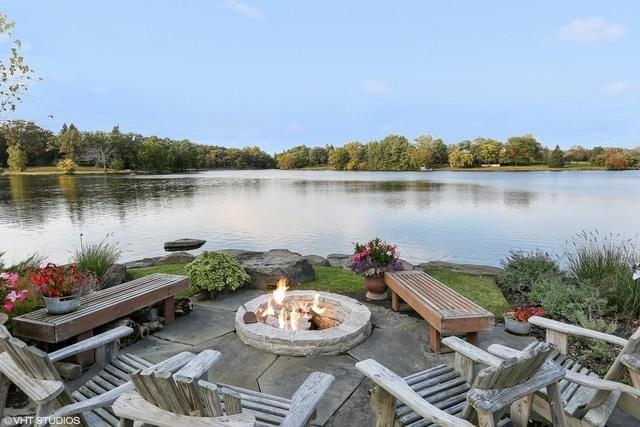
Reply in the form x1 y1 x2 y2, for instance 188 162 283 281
127 264 509 319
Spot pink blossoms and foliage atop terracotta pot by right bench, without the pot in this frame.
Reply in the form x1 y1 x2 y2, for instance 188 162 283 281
351 237 402 277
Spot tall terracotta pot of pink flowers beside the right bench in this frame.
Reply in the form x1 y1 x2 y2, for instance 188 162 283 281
351 237 402 300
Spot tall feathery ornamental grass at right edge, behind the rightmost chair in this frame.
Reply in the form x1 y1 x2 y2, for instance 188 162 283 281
566 231 640 317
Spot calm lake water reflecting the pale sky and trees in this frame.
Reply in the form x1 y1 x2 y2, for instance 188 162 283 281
0 170 640 265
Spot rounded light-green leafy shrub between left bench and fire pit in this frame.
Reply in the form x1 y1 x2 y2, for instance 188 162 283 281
185 252 250 291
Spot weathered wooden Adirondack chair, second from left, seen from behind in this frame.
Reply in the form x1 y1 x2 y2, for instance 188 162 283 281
113 350 333 427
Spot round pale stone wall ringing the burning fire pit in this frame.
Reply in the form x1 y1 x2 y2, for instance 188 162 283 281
235 291 371 356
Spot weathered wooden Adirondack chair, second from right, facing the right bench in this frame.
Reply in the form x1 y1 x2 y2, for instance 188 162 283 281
356 337 566 427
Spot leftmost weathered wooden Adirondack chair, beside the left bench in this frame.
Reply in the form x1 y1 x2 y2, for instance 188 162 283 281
0 326 193 427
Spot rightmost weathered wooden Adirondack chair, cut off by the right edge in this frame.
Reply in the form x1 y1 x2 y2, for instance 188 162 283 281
488 316 640 426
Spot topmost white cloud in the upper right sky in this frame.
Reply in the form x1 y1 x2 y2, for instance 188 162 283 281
554 17 627 45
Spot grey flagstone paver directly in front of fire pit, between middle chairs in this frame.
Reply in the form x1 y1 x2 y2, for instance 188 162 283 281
258 355 364 425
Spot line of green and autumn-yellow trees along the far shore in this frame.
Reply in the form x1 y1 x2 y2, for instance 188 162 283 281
0 120 640 173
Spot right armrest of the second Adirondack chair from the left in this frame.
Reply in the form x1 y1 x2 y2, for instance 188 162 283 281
280 372 335 427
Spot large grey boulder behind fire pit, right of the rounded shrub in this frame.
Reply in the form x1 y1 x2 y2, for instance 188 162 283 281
236 249 316 289
